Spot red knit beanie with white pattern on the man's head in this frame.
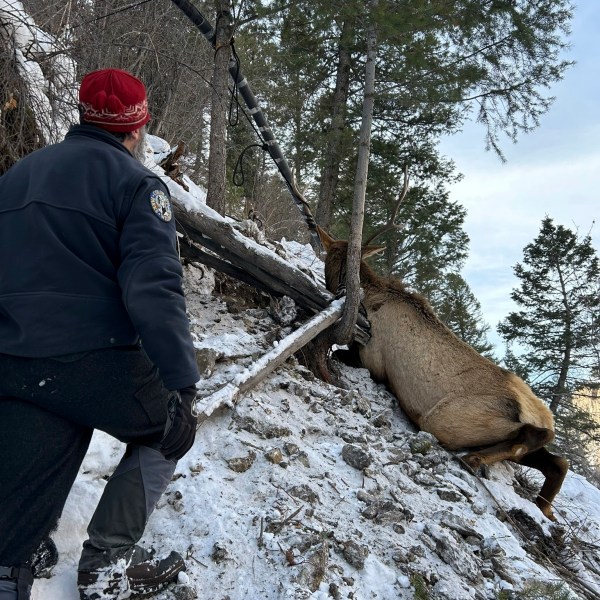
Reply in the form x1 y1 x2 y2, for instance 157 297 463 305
79 69 150 132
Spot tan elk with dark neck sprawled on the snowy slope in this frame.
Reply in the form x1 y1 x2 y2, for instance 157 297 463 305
319 229 568 520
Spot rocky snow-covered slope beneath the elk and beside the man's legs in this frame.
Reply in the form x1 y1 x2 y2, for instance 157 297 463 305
33 250 600 600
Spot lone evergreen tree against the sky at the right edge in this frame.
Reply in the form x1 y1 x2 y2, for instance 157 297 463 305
498 217 600 412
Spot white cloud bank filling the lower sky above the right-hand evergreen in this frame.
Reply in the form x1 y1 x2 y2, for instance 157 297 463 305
440 151 600 350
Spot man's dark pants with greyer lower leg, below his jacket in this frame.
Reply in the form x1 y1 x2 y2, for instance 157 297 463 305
0 347 175 580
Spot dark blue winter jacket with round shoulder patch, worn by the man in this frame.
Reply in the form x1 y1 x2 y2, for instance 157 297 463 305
0 125 199 389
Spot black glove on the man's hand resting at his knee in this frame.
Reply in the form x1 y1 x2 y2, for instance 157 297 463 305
160 385 198 461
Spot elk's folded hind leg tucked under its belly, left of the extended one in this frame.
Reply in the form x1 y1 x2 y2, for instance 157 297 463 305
463 425 554 470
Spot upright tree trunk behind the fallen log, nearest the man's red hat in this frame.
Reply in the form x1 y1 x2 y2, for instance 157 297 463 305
206 0 232 215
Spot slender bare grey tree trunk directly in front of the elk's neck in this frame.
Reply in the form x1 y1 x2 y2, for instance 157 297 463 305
334 0 378 344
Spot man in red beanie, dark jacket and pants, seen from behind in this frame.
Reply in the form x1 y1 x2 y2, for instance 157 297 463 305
0 69 199 600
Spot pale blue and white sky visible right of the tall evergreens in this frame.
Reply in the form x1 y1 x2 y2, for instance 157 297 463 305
441 0 600 355
